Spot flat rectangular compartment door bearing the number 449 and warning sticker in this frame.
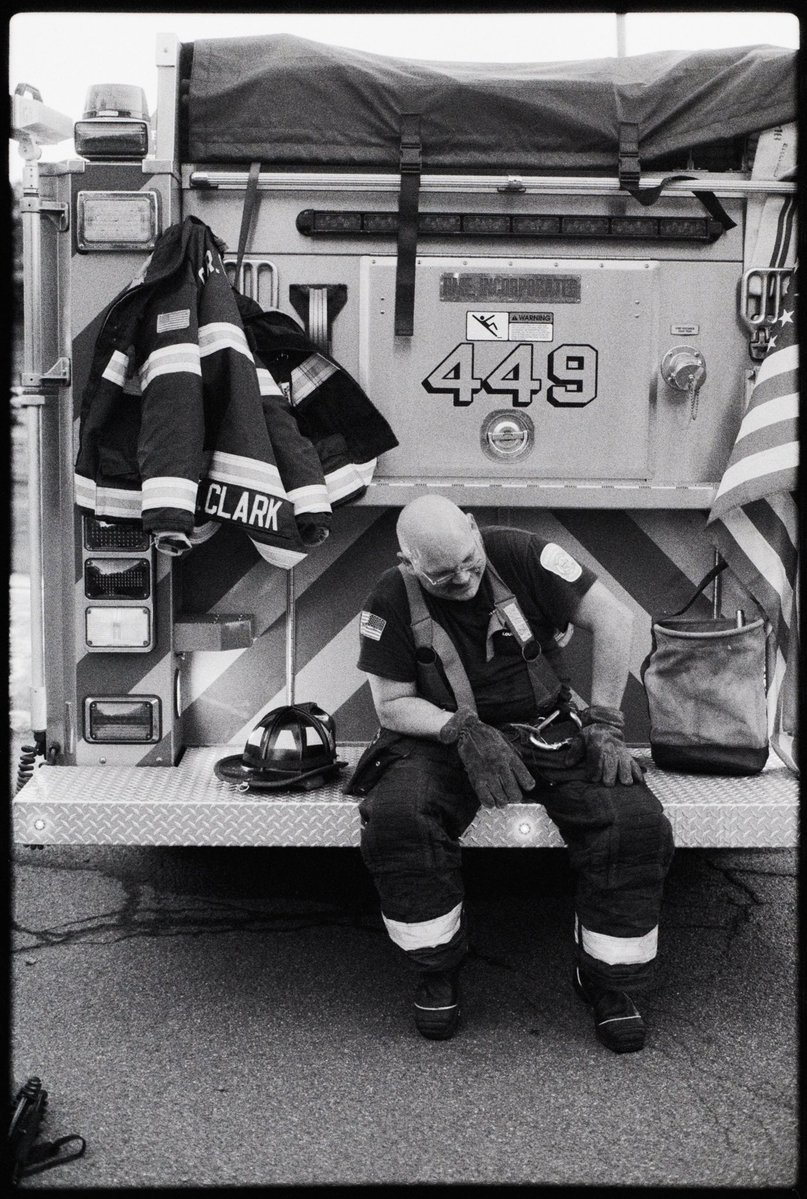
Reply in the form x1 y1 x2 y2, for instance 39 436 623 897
360 258 658 480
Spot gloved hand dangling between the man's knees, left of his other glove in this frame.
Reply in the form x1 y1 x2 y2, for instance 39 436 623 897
439 707 535 808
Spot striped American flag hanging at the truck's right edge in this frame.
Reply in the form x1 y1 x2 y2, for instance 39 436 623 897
707 271 799 773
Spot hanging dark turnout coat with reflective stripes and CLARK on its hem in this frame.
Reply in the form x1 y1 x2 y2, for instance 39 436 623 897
76 217 314 567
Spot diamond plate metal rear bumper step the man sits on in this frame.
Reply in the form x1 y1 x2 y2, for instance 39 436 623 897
12 745 799 849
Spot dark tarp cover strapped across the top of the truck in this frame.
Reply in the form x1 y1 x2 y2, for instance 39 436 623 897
183 34 796 173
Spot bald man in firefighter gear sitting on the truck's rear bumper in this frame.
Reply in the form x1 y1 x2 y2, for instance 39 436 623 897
348 496 673 1053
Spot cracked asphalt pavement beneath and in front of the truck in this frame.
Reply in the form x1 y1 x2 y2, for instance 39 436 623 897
11 845 799 1189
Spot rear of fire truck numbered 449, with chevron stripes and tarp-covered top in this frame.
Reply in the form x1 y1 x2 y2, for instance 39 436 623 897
12 35 796 848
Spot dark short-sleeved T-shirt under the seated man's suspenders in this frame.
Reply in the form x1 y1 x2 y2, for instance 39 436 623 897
359 525 596 724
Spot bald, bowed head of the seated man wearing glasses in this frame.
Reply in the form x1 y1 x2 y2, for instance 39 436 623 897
396 495 486 600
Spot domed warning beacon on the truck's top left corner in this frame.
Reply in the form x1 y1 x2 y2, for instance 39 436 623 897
73 83 150 162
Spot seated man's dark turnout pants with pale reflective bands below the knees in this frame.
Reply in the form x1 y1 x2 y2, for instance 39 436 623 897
359 729 673 992
